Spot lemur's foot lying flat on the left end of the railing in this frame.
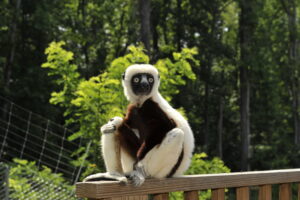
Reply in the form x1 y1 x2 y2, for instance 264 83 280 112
83 172 128 183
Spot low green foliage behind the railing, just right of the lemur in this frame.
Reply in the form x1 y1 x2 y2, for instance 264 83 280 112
170 153 230 200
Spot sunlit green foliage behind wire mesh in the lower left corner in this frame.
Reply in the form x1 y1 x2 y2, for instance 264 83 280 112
9 159 76 200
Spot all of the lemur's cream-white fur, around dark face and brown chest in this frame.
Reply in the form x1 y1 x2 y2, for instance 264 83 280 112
86 64 194 185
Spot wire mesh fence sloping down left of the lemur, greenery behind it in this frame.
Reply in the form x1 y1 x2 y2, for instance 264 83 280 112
0 95 89 200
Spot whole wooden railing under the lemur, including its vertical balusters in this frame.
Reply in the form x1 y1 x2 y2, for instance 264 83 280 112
76 169 300 200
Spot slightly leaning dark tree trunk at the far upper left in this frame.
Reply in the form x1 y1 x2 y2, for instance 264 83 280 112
3 0 21 92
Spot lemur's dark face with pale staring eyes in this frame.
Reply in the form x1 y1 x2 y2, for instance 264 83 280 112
131 73 154 95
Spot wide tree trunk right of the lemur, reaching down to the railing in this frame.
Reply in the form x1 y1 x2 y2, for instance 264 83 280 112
239 0 255 171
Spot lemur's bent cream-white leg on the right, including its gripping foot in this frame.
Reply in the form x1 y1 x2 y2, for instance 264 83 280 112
126 128 184 186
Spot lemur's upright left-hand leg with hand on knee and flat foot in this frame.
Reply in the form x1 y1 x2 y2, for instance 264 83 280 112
84 117 127 182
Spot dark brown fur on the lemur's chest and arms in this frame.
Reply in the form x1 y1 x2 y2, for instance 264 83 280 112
118 99 176 161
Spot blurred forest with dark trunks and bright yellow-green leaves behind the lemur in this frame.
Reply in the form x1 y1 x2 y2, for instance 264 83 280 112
0 0 300 193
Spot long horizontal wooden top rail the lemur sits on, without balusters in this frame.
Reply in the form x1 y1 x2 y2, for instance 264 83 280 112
76 169 300 199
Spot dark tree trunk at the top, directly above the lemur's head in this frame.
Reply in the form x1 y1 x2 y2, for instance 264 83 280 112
139 0 151 55
